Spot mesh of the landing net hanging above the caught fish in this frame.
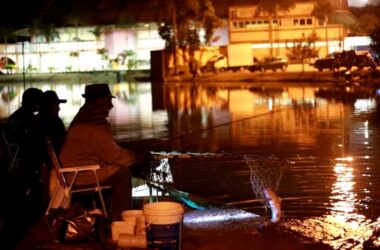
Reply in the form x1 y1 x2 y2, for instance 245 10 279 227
244 156 289 203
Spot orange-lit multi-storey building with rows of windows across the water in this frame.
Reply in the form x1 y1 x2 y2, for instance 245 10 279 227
228 1 348 57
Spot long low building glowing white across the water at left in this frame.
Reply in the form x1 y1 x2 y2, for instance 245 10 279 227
0 23 165 73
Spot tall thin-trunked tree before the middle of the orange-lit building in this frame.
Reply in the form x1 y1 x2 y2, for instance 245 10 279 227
255 0 295 56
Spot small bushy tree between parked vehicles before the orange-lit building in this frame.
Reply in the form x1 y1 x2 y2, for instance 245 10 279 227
286 33 319 72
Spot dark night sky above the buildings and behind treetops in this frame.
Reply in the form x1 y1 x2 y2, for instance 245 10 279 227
0 0 380 28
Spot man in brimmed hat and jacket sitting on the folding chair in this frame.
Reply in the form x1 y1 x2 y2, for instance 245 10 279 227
60 83 139 220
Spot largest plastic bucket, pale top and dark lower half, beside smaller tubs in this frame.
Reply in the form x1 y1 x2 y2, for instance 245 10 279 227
143 201 183 250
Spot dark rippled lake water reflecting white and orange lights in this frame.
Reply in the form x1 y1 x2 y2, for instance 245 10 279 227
0 82 380 249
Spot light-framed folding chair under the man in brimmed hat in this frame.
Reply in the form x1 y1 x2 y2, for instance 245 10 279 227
45 139 111 218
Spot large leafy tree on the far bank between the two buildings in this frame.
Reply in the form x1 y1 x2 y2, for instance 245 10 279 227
159 0 223 77
